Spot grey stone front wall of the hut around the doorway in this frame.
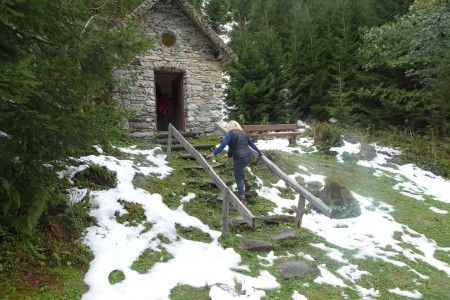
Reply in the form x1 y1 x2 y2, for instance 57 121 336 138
115 2 224 138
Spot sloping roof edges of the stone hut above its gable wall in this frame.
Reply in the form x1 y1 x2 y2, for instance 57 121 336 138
128 0 238 66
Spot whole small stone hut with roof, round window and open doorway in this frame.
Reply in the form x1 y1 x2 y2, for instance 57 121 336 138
115 0 238 139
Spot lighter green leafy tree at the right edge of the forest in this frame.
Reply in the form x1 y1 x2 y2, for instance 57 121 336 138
362 0 450 139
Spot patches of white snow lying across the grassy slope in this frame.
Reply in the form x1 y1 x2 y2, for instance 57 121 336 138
59 135 450 300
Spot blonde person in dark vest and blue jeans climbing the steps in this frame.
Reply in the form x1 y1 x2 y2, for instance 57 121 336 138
206 120 263 205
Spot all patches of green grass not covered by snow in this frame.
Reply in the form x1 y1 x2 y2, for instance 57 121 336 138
0 132 450 300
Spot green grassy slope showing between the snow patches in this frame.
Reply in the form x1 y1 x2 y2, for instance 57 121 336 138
0 138 450 300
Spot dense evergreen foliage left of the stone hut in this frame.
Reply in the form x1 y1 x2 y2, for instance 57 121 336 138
0 0 149 232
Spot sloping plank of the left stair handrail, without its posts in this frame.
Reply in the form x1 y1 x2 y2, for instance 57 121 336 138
169 124 256 227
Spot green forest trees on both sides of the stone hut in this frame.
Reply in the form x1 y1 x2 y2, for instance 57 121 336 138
0 0 450 296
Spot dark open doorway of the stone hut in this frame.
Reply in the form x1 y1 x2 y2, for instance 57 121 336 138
155 72 185 131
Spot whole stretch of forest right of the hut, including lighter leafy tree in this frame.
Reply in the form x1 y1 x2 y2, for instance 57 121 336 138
200 0 450 177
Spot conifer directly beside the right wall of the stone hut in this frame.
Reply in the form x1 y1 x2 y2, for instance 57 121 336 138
225 1 288 123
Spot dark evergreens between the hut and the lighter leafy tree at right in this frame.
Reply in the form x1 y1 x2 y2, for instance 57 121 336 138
222 0 422 129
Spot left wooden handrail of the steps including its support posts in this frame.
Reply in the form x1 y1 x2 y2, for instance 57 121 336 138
167 124 256 236
